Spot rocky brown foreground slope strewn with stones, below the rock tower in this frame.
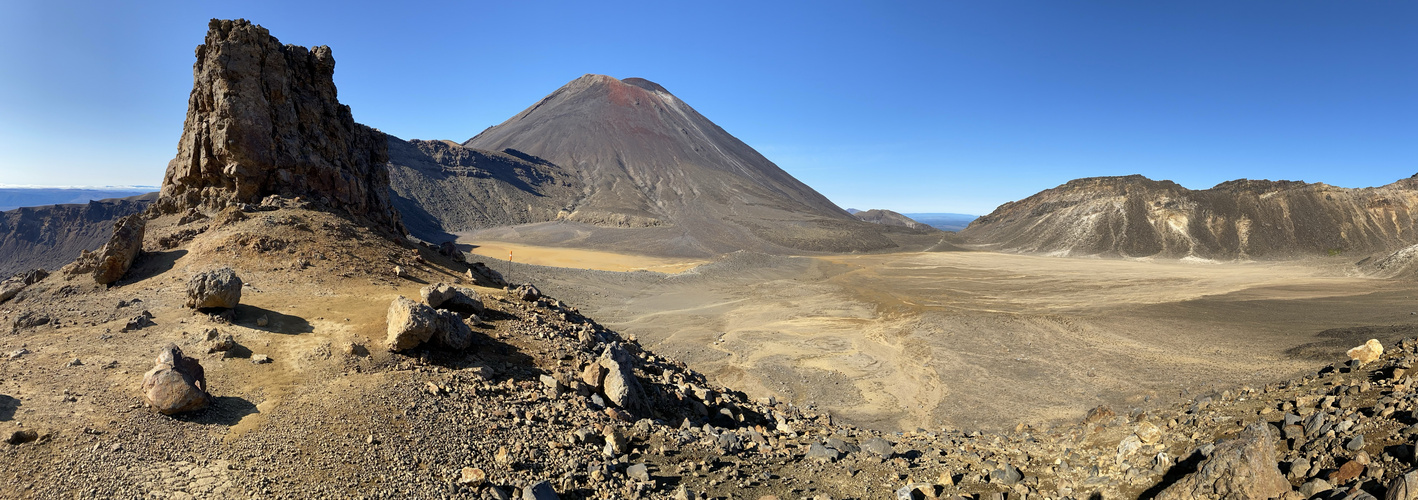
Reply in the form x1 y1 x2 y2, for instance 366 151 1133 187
8 203 1418 499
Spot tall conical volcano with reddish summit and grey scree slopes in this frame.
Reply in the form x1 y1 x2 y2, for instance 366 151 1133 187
462 75 900 254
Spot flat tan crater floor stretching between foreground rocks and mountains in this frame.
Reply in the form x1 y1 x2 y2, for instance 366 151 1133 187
485 244 1418 429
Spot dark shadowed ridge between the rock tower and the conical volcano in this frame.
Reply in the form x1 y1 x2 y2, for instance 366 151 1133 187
386 136 583 242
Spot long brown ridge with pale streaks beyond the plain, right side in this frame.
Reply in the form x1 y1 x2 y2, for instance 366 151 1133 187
961 176 1418 259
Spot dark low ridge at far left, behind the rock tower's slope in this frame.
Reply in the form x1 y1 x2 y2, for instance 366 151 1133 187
0 193 157 276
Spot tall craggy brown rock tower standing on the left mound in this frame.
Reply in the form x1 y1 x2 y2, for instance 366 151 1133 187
155 20 404 237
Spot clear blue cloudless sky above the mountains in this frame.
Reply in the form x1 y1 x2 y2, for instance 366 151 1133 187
0 0 1418 214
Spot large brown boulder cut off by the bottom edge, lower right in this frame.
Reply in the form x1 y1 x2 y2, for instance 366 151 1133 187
1157 422 1290 500
